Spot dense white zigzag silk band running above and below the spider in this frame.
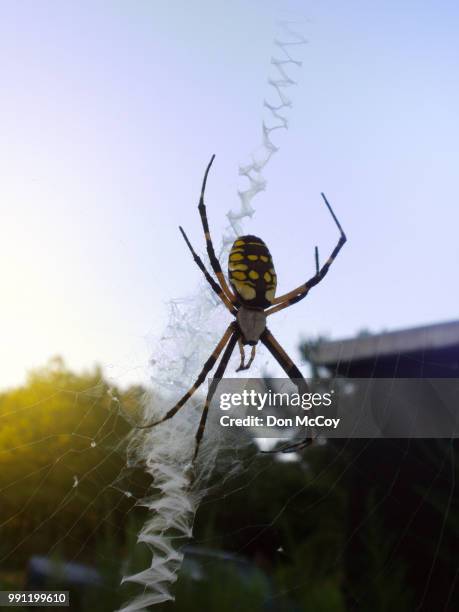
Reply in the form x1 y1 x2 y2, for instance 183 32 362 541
114 16 306 612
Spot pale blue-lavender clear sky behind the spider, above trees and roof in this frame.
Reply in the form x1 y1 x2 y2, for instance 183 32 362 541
0 0 459 388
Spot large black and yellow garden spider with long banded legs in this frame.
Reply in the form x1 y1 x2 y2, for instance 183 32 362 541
138 155 346 463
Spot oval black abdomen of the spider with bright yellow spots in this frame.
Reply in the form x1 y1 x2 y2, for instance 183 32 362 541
228 236 277 308
